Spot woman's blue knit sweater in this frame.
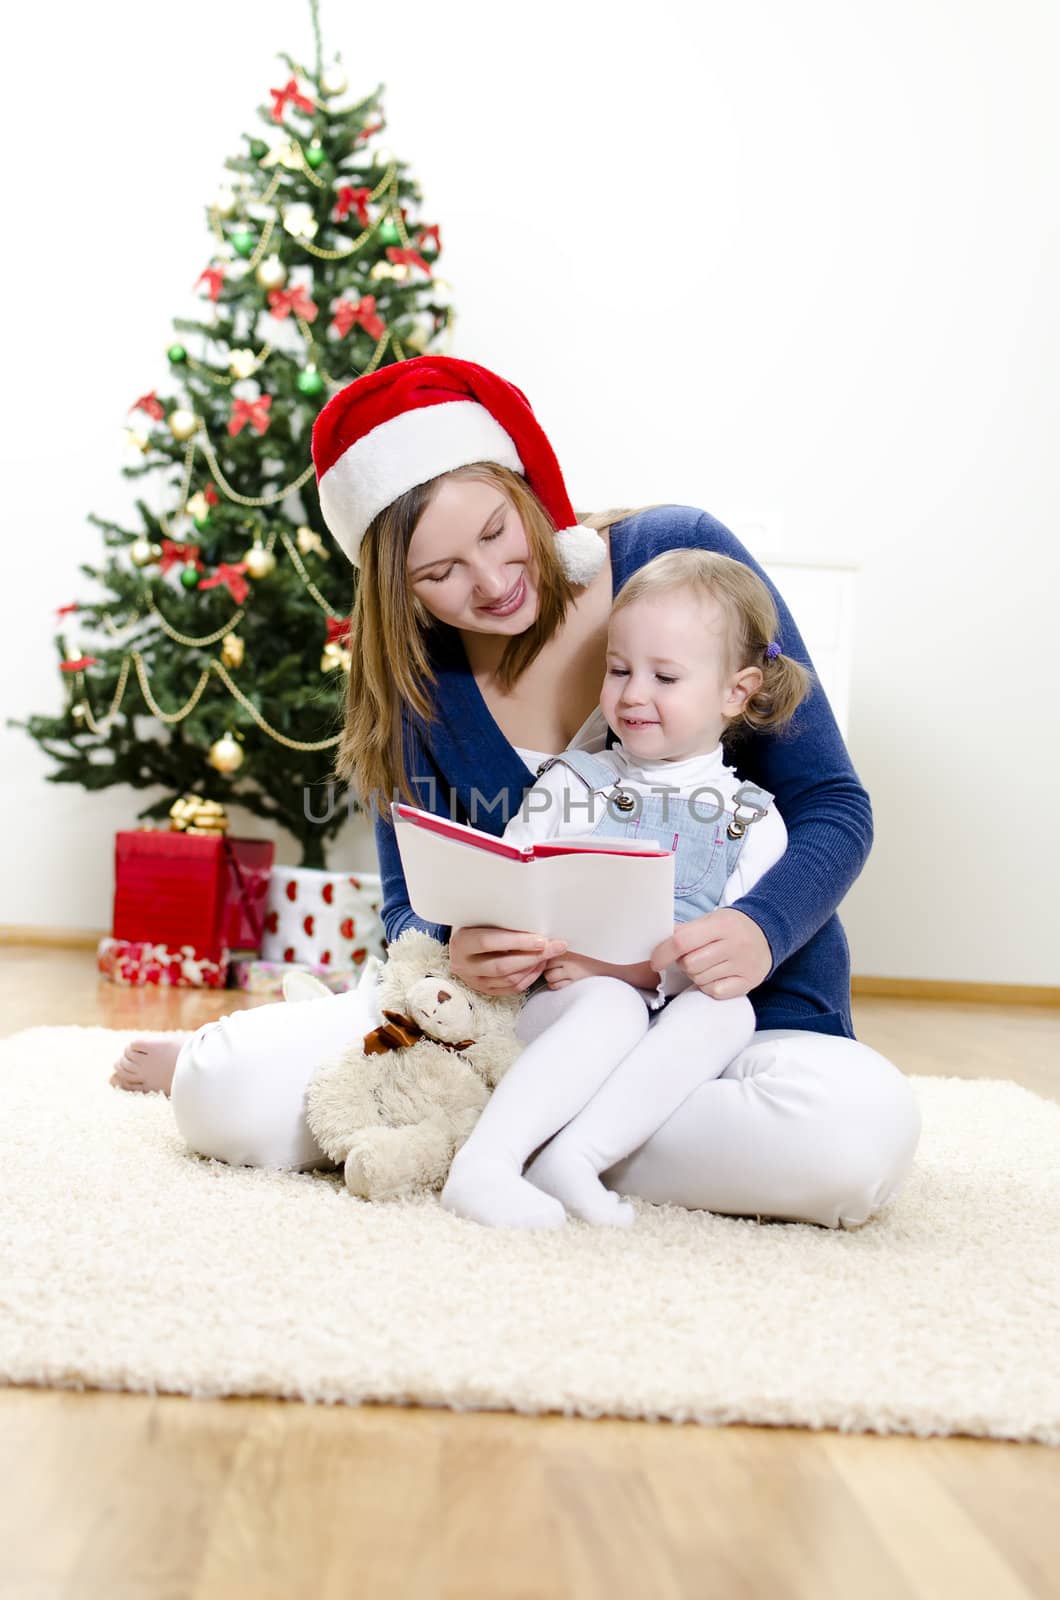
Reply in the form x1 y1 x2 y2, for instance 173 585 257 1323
375 506 873 1038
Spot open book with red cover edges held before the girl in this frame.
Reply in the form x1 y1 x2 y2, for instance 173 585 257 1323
391 802 674 965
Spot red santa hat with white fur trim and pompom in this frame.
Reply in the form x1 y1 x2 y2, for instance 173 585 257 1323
312 355 605 584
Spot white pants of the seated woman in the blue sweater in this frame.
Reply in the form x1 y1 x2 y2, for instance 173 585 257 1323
171 987 921 1227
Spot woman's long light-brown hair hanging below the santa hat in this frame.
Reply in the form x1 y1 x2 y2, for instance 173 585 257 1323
335 461 659 818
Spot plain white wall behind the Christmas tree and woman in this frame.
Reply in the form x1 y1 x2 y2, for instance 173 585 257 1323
0 0 1060 984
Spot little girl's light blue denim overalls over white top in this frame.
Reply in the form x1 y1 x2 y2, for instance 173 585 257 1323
538 750 773 923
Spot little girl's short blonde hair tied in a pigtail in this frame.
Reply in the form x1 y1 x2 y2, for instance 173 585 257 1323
612 550 815 741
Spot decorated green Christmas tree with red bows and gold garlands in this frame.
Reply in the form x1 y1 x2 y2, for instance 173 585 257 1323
11 0 452 867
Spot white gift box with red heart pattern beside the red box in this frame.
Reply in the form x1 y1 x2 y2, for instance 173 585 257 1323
261 867 386 971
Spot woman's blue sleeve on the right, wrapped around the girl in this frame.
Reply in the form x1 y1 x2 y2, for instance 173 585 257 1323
695 512 873 976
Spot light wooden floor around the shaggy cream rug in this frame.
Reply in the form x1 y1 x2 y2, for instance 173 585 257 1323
0 949 1060 1600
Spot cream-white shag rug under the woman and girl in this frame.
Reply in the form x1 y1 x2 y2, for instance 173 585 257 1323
0 1027 1060 1445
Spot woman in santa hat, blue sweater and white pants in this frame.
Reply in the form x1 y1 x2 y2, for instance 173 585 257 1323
117 355 921 1227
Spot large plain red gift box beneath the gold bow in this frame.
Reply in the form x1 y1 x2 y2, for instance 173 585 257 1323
114 829 274 962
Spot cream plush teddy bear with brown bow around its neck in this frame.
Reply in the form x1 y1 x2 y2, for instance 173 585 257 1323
302 928 524 1200
